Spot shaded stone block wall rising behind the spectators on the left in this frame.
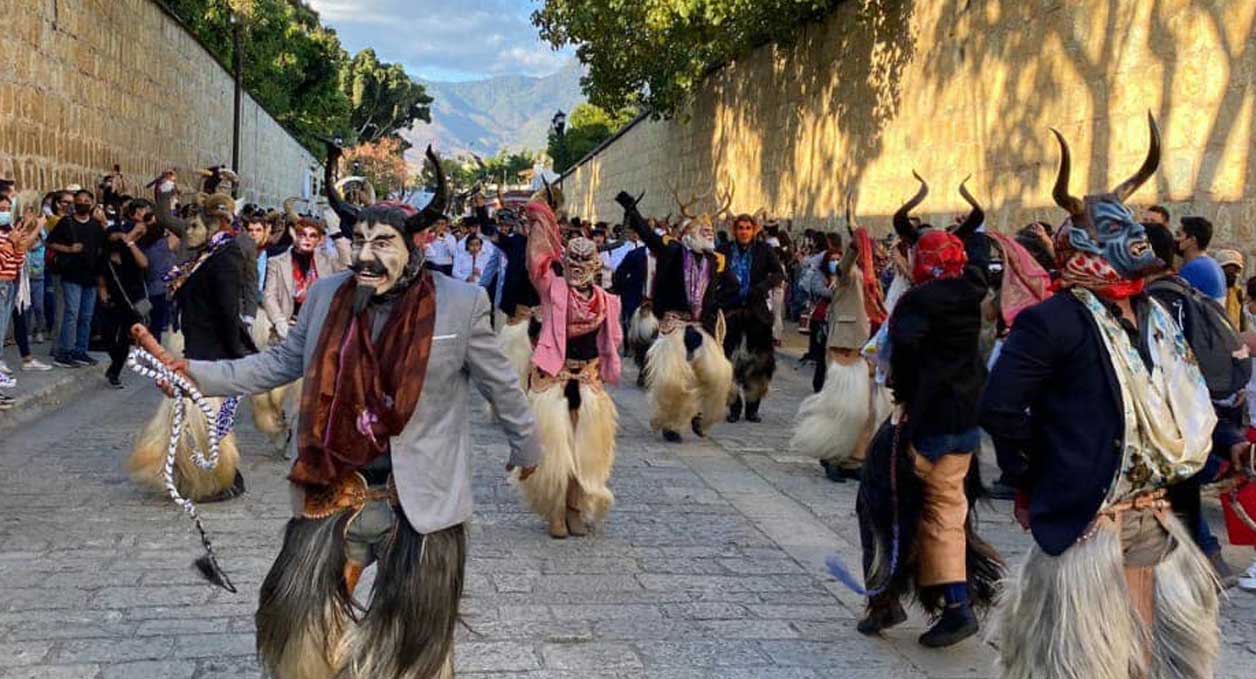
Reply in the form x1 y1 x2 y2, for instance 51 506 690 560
0 0 322 206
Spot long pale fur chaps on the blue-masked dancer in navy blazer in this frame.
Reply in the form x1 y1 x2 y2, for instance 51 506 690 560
993 504 1221 679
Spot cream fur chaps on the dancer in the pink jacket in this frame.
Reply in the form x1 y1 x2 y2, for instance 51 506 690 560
520 380 619 525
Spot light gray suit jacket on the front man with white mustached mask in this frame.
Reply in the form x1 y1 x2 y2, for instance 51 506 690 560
188 272 540 533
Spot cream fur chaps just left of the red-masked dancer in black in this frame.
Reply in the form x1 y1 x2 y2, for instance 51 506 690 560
790 359 891 464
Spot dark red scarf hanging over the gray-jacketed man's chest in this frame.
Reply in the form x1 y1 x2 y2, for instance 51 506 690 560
288 271 436 486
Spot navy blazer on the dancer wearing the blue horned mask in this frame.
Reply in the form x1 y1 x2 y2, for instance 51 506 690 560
980 292 1145 556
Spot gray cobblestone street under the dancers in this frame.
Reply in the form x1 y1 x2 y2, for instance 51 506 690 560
0 359 1256 679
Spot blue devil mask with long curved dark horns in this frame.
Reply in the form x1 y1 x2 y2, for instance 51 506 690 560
1051 113 1164 280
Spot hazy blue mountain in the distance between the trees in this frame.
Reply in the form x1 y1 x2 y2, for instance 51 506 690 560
402 59 584 163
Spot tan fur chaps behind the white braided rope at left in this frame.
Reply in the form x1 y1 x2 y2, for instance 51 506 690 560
127 398 240 501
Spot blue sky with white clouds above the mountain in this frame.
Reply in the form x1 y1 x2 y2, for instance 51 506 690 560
309 0 573 80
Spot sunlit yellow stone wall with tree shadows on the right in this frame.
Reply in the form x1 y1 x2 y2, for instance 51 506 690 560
564 0 1256 243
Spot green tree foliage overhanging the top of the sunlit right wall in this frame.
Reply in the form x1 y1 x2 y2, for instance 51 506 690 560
533 0 842 115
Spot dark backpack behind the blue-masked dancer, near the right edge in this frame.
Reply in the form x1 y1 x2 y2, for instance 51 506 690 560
1147 276 1252 400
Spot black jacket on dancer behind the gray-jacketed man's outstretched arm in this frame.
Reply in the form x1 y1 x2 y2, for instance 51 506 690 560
176 243 257 360
